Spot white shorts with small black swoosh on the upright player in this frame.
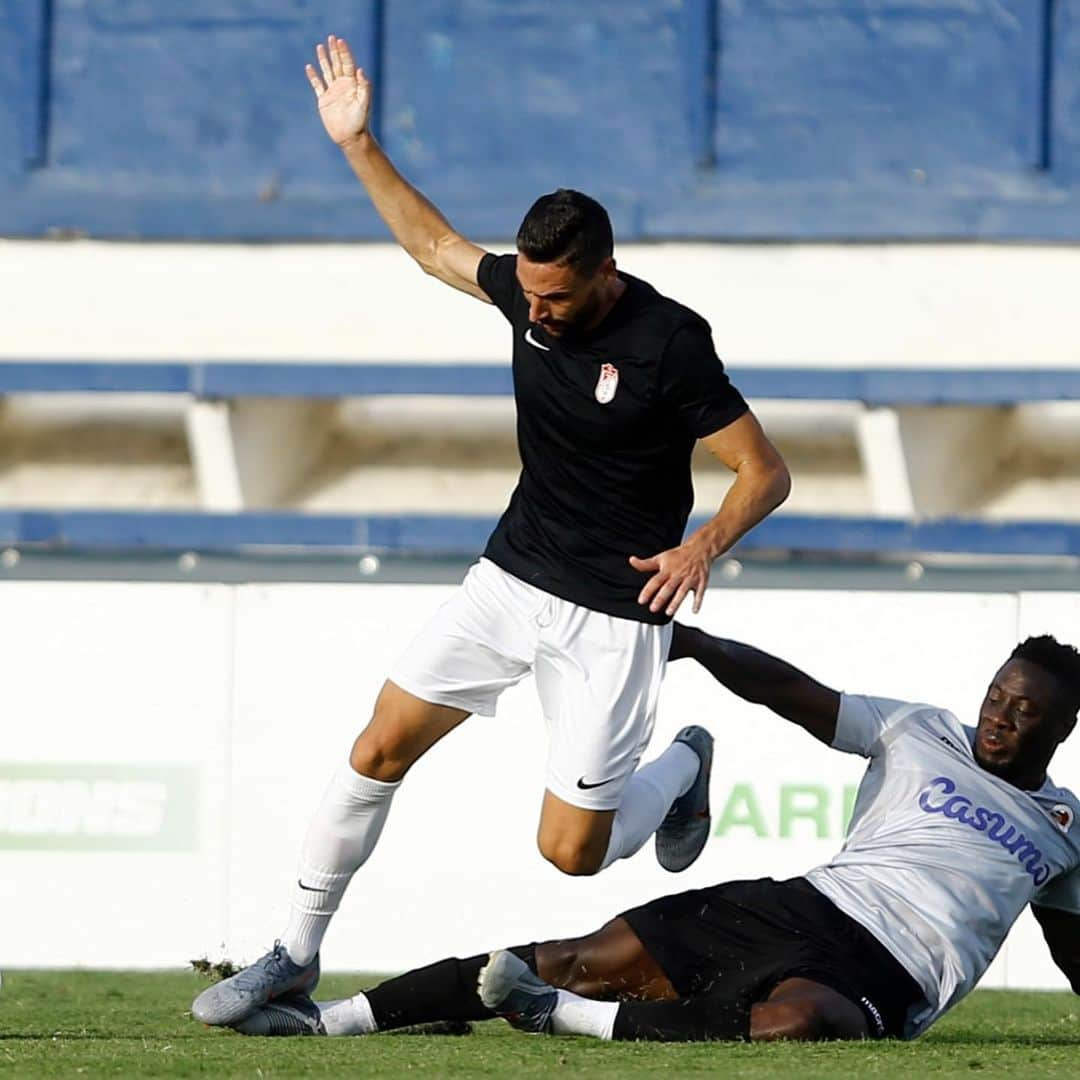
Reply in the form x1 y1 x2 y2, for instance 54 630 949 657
389 558 672 810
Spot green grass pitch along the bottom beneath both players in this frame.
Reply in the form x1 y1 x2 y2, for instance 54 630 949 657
0 971 1080 1080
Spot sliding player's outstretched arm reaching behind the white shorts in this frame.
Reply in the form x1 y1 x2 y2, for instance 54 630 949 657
669 622 840 746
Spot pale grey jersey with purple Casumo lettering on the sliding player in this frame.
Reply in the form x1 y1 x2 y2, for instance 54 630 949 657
806 694 1080 1038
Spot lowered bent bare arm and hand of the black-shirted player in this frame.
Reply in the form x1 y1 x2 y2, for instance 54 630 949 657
630 409 792 615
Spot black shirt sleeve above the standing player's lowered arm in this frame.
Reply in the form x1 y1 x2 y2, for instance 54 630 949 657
660 324 747 438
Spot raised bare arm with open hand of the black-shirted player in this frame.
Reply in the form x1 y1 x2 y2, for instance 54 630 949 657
305 35 491 303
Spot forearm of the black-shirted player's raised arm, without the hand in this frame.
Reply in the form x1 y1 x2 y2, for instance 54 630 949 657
341 132 457 273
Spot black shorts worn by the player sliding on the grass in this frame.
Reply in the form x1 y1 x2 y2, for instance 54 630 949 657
616 878 923 1039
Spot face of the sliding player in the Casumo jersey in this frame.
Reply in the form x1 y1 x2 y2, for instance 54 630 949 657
975 660 1069 783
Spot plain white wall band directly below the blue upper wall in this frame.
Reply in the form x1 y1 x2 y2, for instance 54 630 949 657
6 240 1080 367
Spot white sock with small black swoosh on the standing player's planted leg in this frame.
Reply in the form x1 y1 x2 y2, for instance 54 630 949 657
281 761 399 964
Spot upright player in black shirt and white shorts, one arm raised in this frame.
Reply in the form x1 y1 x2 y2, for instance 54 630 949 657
192 37 791 1025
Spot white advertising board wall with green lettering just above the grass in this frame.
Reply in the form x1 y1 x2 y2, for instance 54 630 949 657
0 583 1080 987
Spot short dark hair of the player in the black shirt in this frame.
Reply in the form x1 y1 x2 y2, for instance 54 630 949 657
517 188 615 274
